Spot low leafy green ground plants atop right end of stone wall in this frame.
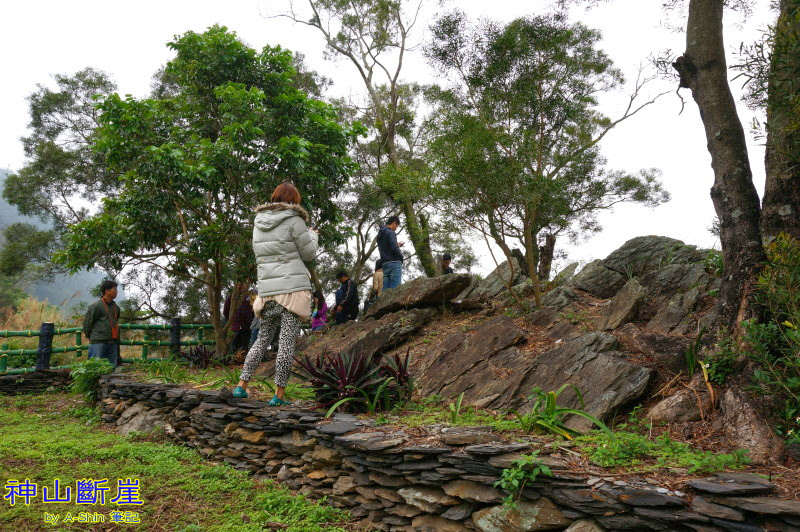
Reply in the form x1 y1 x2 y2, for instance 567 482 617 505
575 431 750 474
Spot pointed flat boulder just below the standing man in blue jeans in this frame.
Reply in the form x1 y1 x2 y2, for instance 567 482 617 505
364 273 472 318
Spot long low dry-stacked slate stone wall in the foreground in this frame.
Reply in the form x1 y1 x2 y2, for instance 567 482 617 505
101 375 800 532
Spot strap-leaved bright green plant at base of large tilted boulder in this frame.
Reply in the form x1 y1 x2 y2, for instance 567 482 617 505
511 383 609 439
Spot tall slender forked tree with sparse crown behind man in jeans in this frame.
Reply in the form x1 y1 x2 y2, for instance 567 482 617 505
278 0 436 276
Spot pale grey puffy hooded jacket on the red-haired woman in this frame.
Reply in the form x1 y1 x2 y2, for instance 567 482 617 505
253 203 319 296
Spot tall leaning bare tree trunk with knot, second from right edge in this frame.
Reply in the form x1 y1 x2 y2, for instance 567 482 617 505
673 0 764 328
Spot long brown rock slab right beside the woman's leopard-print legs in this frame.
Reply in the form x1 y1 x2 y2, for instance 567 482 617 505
297 308 439 356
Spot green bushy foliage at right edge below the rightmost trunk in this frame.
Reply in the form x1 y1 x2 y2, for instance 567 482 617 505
744 234 800 439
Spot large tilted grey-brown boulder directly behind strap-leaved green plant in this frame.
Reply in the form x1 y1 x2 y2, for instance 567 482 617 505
520 332 655 430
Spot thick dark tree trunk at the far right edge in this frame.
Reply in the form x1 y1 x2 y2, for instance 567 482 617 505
761 0 800 242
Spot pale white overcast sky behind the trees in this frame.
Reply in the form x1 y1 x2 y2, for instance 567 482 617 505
0 0 773 274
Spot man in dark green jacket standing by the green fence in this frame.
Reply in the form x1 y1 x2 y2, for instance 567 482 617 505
83 280 119 367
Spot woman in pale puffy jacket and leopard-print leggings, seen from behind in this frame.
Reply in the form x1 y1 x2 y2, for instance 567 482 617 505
233 183 319 406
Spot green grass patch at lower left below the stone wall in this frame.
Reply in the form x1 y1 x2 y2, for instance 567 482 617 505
0 388 347 532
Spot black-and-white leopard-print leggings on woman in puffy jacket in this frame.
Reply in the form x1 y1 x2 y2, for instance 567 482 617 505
239 301 300 388
